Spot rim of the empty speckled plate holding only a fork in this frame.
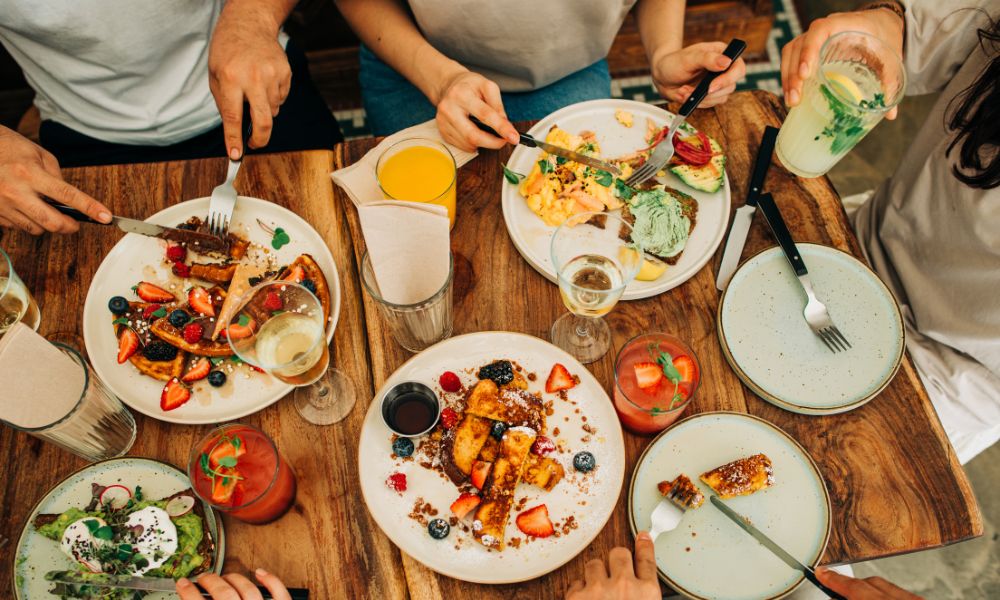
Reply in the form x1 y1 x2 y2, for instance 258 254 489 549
715 242 906 416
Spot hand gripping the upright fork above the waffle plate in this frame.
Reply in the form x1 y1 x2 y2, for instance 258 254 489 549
208 4 292 160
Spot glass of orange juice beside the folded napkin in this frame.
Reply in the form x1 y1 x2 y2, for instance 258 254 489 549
375 138 458 227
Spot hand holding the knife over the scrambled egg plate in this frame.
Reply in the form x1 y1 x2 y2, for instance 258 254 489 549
436 70 519 152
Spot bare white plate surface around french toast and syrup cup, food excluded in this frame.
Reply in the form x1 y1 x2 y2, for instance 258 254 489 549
358 332 625 583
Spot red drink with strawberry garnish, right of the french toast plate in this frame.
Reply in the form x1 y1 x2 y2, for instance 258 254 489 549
615 333 701 435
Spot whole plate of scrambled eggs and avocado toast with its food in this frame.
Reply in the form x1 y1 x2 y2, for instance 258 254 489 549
501 99 730 300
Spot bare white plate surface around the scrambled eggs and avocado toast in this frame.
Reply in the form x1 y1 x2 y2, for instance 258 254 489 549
501 99 729 300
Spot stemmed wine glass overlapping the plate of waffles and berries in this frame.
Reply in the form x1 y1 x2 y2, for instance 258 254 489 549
227 281 356 425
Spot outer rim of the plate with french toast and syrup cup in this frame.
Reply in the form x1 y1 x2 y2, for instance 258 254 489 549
357 330 627 585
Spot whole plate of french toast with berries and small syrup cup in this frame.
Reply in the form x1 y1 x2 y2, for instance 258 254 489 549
358 332 625 584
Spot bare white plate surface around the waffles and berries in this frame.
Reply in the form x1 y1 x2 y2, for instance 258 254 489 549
83 196 340 425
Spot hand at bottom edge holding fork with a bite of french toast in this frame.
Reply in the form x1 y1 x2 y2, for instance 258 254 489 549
566 531 661 600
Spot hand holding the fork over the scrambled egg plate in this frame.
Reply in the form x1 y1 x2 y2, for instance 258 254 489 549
652 42 747 108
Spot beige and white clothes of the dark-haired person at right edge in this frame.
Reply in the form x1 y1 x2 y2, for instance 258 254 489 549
854 0 1000 462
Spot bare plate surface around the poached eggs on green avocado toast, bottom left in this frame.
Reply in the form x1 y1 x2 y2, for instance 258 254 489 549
11 457 226 600
